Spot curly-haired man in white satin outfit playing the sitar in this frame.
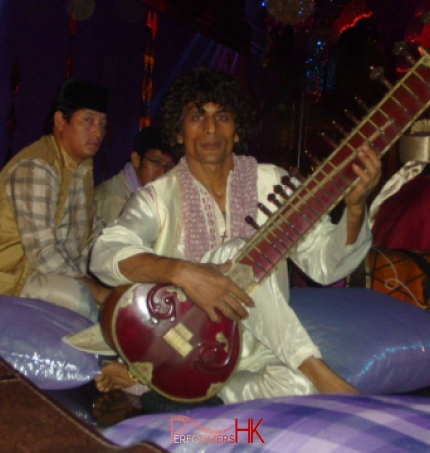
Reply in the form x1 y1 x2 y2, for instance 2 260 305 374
91 68 381 403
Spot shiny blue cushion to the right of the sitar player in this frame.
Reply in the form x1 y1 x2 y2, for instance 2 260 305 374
290 288 430 394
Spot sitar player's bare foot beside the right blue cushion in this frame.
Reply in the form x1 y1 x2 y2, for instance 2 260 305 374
299 357 360 394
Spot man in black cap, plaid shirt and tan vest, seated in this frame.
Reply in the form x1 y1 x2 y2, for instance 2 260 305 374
0 80 109 319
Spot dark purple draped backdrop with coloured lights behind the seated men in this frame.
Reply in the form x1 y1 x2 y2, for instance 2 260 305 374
0 0 430 182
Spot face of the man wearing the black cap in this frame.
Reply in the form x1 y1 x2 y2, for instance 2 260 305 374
54 109 107 163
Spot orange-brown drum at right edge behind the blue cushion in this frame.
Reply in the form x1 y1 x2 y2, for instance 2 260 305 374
365 248 430 309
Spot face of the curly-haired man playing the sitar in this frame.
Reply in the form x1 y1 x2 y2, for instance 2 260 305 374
177 102 239 164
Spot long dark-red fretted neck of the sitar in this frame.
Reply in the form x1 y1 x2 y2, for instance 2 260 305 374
235 50 430 290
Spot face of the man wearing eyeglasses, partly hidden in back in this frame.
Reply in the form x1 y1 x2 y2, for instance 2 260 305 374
131 149 175 186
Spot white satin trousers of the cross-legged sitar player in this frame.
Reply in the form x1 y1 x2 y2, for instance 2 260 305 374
203 239 321 403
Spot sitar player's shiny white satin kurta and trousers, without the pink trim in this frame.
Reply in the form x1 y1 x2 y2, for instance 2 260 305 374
91 164 371 403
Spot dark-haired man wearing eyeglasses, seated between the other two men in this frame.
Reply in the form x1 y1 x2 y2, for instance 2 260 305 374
95 127 175 223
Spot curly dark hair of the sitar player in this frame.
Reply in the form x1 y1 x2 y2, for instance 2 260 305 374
161 68 255 155
